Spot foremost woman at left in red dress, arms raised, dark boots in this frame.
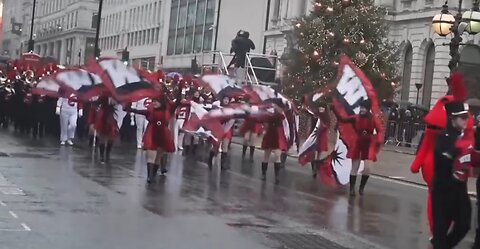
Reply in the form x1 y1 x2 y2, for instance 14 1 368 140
128 96 180 183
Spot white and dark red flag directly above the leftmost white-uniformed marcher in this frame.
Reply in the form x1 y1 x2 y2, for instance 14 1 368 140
52 69 105 101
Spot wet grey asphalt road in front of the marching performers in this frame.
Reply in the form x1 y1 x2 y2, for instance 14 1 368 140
0 131 473 249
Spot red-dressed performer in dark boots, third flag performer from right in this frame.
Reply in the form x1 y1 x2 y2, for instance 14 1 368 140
258 99 288 184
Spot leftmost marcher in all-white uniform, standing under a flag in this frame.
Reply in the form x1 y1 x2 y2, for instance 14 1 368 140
55 94 83 145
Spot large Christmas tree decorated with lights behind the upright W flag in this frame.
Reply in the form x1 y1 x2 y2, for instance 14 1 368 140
283 0 399 100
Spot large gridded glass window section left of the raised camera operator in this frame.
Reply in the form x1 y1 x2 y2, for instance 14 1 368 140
167 0 216 55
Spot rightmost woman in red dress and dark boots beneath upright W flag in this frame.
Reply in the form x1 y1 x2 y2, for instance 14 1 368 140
337 99 383 196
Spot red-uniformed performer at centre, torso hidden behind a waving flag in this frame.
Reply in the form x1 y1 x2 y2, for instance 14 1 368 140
208 97 235 170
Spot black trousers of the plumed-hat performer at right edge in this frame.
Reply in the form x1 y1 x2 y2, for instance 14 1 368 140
432 184 472 249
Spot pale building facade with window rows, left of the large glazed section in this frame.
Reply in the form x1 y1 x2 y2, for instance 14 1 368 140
99 0 165 70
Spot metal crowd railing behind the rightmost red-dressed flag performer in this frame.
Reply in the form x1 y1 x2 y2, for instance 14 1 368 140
385 120 425 147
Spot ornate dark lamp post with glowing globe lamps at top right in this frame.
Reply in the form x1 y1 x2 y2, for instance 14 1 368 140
432 0 480 72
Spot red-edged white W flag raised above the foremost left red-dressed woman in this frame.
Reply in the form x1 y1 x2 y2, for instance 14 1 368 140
88 58 161 104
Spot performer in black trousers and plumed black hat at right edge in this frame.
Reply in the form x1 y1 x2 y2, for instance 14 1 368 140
431 95 474 249
